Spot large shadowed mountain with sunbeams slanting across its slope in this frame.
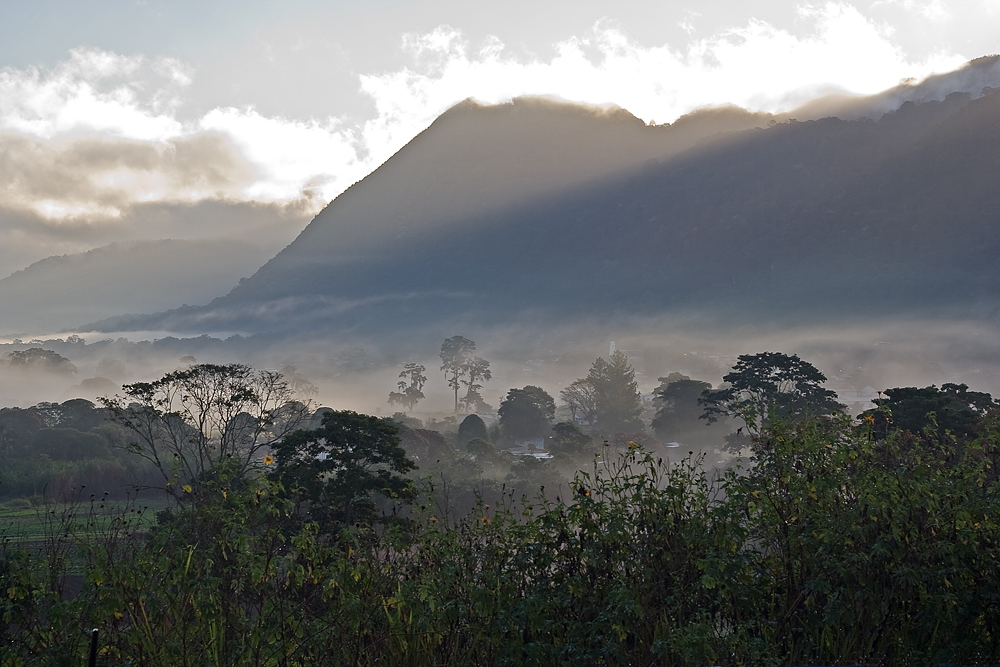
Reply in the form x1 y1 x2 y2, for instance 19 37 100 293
88 58 1000 335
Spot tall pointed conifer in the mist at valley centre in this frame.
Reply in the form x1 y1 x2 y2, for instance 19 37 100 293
587 350 643 435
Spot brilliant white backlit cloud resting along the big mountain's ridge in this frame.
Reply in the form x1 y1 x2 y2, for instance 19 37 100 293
361 3 966 142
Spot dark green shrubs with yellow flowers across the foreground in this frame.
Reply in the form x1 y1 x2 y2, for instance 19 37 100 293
0 413 1000 667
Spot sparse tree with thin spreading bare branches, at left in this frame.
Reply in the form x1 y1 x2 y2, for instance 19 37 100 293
100 364 310 492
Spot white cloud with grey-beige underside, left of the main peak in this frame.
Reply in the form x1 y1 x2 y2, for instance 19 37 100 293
0 49 365 235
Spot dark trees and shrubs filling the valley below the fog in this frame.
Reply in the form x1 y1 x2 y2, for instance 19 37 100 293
0 348 1000 666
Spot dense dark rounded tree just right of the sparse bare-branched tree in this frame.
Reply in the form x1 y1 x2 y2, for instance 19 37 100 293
272 410 416 531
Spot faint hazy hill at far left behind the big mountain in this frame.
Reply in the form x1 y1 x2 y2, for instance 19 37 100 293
0 240 273 334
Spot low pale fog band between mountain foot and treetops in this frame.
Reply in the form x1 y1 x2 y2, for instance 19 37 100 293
0 318 1000 419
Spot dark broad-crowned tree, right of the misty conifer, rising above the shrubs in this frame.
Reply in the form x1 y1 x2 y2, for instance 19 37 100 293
699 352 844 434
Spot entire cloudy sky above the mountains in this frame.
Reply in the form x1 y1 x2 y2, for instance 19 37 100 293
0 0 1000 278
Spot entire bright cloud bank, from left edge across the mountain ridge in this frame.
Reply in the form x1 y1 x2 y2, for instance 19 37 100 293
0 3 964 277
